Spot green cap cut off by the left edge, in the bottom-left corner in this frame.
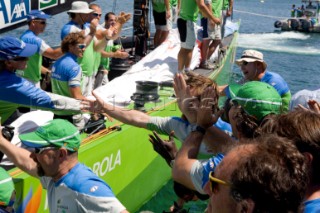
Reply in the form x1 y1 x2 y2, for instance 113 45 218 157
0 167 14 206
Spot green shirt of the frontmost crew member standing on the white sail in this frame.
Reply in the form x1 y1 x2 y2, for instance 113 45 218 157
180 0 199 22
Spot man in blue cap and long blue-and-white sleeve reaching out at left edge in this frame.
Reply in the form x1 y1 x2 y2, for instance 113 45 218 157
0 36 93 124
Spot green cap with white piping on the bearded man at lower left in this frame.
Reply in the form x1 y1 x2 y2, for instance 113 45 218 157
19 119 81 151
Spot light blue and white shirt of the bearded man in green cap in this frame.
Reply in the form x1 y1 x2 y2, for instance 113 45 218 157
40 163 125 213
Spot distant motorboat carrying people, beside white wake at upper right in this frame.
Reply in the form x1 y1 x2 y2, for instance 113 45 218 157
274 0 320 33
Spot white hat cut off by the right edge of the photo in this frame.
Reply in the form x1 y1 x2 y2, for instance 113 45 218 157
289 89 320 111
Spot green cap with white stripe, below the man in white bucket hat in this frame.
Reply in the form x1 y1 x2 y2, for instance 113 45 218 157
229 81 282 121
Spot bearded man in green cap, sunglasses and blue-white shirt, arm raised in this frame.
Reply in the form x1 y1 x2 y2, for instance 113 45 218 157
0 119 128 213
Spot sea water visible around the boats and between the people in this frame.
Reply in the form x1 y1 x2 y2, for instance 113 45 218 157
0 0 320 213
